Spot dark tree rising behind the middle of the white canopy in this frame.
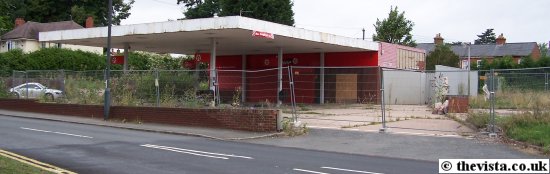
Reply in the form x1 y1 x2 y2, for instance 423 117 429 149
177 0 294 25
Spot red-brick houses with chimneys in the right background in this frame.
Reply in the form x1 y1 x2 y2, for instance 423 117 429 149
416 34 540 69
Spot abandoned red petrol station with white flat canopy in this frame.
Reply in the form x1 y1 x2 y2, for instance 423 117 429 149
39 16 425 103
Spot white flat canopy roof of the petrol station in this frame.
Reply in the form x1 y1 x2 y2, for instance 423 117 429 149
39 16 378 55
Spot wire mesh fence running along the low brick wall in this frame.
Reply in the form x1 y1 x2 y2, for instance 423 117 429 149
0 68 290 108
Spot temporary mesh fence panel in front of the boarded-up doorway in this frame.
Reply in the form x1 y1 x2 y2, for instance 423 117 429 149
289 67 381 130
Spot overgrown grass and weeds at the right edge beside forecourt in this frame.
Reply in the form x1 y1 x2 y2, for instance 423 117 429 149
466 90 550 153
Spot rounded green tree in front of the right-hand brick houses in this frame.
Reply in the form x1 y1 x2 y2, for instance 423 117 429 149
426 44 460 70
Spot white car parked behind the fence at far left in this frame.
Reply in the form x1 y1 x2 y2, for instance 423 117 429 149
9 82 63 100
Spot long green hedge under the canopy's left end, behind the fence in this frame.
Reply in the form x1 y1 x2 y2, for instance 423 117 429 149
0 48 189 76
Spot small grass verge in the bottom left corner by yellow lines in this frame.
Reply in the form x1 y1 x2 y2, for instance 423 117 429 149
0 155 53 174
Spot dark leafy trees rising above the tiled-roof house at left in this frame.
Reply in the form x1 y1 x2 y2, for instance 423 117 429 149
0 0 134 26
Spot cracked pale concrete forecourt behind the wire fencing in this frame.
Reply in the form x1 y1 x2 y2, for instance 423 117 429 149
283 104 476 136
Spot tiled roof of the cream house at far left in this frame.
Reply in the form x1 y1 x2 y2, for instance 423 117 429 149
2 21 84 40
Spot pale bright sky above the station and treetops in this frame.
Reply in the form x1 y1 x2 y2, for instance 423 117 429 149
122 0 550 43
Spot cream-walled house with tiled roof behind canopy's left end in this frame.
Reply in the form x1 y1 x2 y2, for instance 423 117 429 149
0 17 103 54
